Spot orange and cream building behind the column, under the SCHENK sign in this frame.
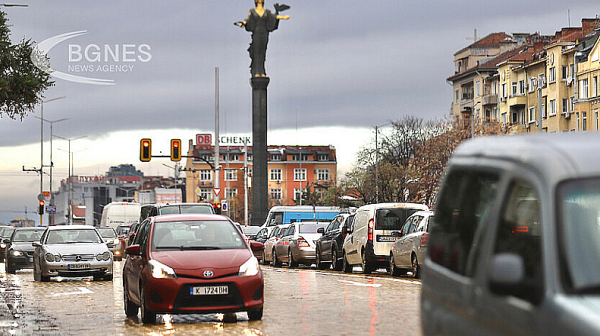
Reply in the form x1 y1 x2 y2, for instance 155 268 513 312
183 140 337 208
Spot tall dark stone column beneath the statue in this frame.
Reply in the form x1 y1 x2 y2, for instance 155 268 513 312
250 77 269 225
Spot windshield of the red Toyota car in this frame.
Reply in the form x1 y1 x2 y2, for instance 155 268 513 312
152 220 246 251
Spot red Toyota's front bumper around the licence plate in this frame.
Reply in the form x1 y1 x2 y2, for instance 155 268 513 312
144 271 264 314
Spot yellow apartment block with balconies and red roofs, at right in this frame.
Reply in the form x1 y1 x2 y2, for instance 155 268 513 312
447 19 600 133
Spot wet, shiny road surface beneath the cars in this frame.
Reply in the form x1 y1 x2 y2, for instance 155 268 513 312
0 262 421 336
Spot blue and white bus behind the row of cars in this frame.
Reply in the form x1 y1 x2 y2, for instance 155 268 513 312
263 205 341 226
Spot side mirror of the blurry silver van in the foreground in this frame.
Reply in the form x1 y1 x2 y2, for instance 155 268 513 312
490 253 527 296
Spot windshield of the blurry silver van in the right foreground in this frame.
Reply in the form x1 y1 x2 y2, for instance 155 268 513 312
558 178 600 292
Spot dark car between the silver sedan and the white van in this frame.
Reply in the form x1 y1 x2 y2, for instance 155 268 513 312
315 213 354 271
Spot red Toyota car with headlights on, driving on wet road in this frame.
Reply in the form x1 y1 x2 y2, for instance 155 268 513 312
123 214 264 323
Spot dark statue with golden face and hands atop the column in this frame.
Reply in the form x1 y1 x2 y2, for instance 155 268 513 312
234 0 290 77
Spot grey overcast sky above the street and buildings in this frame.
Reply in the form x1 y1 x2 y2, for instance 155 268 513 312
0 0 600 222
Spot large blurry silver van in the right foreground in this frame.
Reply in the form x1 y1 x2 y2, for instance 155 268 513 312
420 133 600 336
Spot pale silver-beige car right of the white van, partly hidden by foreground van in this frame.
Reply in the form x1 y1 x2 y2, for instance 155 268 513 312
390 211 433 278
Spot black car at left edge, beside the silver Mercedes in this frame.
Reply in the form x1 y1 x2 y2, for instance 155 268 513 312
2 227 46 274
